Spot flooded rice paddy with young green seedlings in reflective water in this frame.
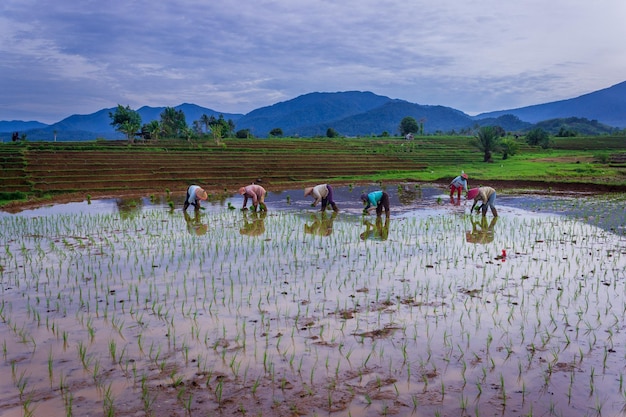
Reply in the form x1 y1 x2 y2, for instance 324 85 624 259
0 184 626 416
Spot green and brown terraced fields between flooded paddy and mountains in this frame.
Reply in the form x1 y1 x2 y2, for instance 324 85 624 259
0 136 626 204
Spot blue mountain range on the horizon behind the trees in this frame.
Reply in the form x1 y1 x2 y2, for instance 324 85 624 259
0 82 626 141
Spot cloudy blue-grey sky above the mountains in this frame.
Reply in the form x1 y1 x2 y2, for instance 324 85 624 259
0 0 626 123
